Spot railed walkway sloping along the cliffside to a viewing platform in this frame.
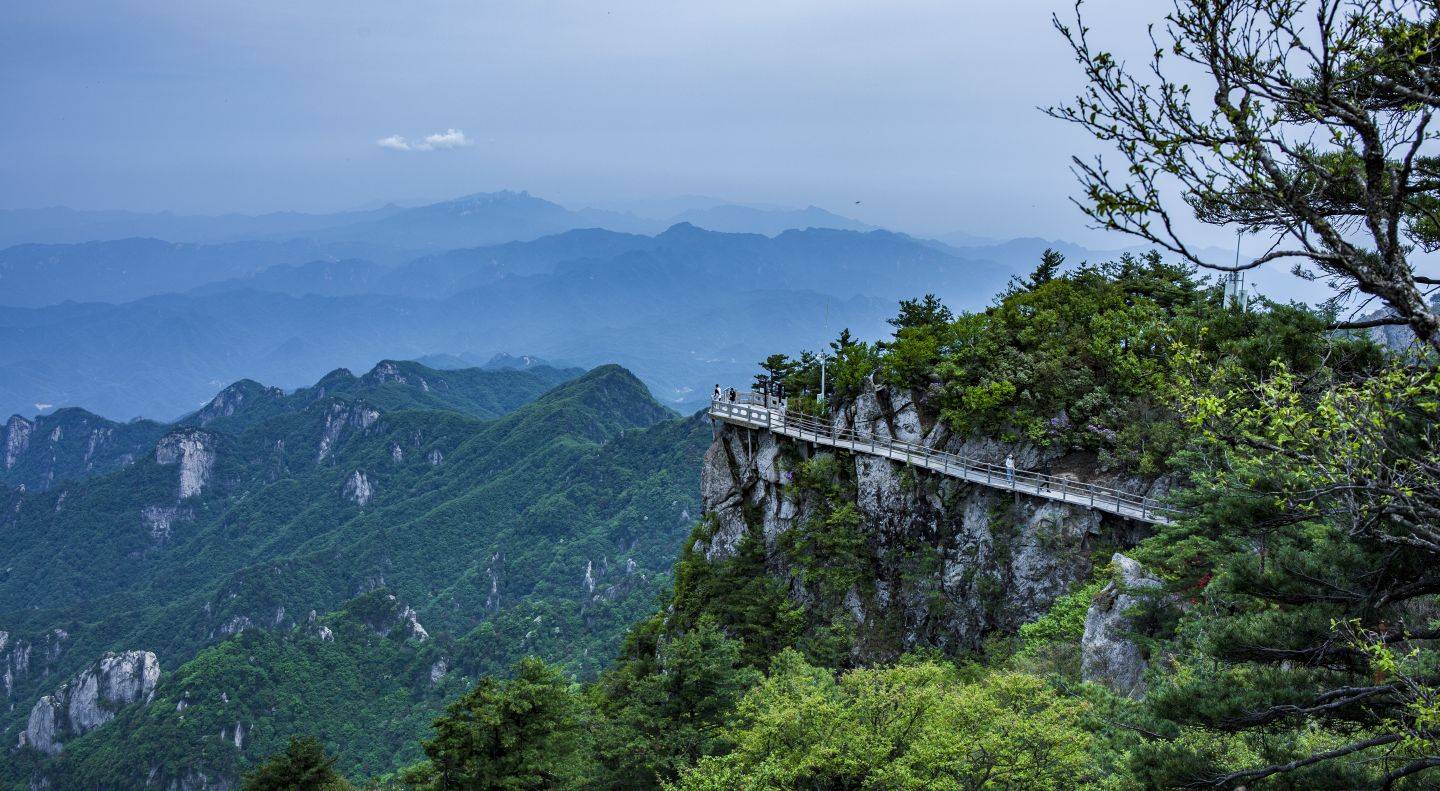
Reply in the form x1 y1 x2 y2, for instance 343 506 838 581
710 393 1174 524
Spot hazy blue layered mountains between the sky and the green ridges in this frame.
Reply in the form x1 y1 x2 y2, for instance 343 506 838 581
0 192 1146 419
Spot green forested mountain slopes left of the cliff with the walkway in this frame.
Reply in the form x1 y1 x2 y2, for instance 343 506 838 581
0 363 708 785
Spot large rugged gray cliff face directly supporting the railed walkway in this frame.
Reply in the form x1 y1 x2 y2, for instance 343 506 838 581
694 385 1156 661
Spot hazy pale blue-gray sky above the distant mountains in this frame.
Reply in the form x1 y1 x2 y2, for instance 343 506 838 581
0 0 1180 241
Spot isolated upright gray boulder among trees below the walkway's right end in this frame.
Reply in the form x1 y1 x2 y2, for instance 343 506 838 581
1080 552 1161 697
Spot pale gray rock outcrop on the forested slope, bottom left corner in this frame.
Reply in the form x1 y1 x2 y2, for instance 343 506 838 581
20 651 160 755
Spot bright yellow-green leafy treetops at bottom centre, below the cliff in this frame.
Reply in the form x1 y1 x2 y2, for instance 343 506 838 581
678 651 1103 791
